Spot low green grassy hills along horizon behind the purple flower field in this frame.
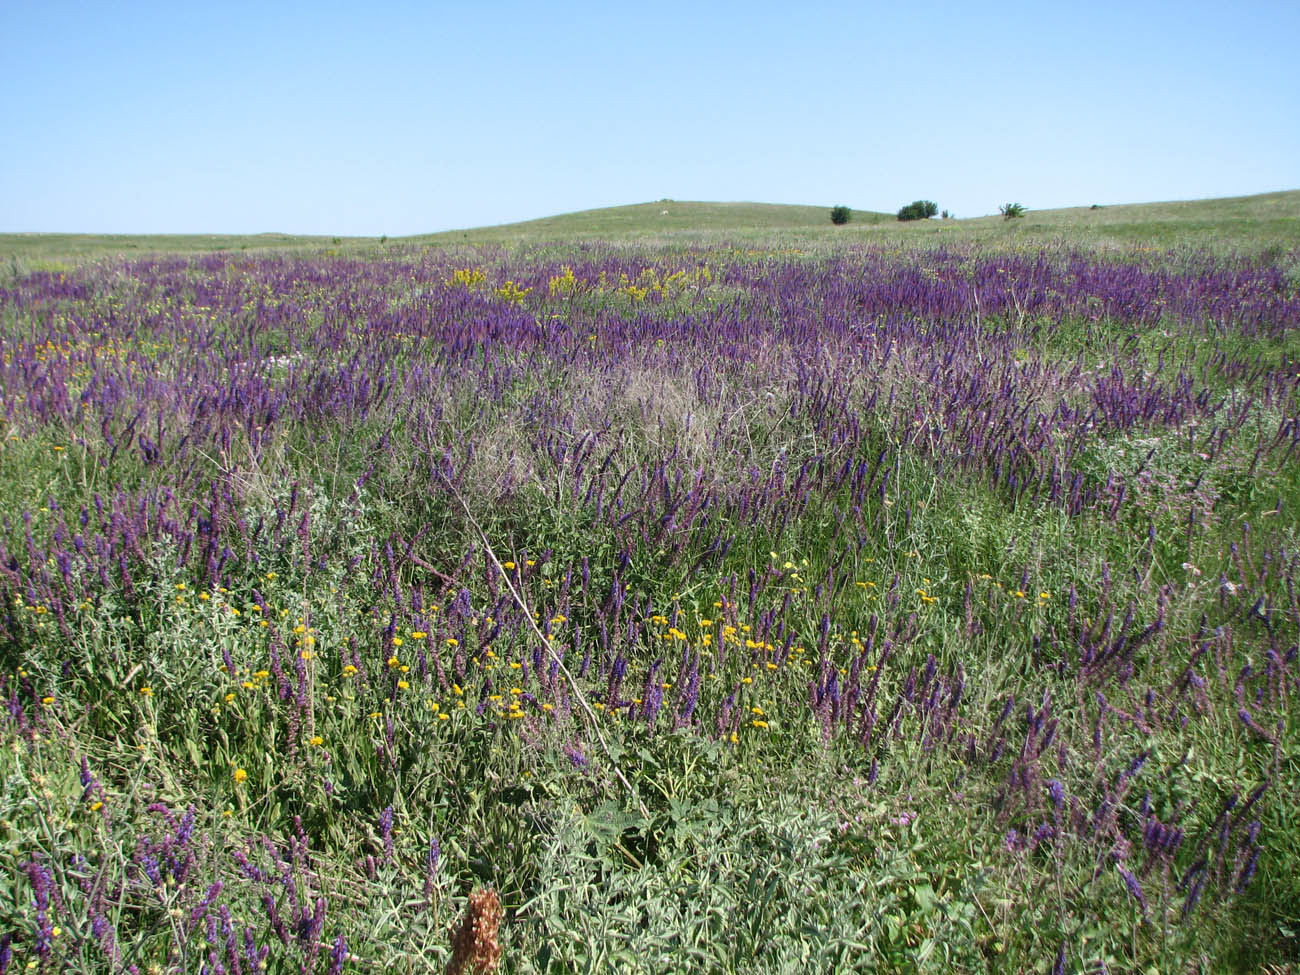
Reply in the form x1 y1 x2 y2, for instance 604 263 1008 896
0 190 1300 273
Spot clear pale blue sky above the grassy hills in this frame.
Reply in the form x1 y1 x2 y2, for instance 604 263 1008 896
0 0 1300 237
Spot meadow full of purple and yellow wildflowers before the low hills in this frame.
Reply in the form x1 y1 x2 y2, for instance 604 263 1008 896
0 194 1300 975
